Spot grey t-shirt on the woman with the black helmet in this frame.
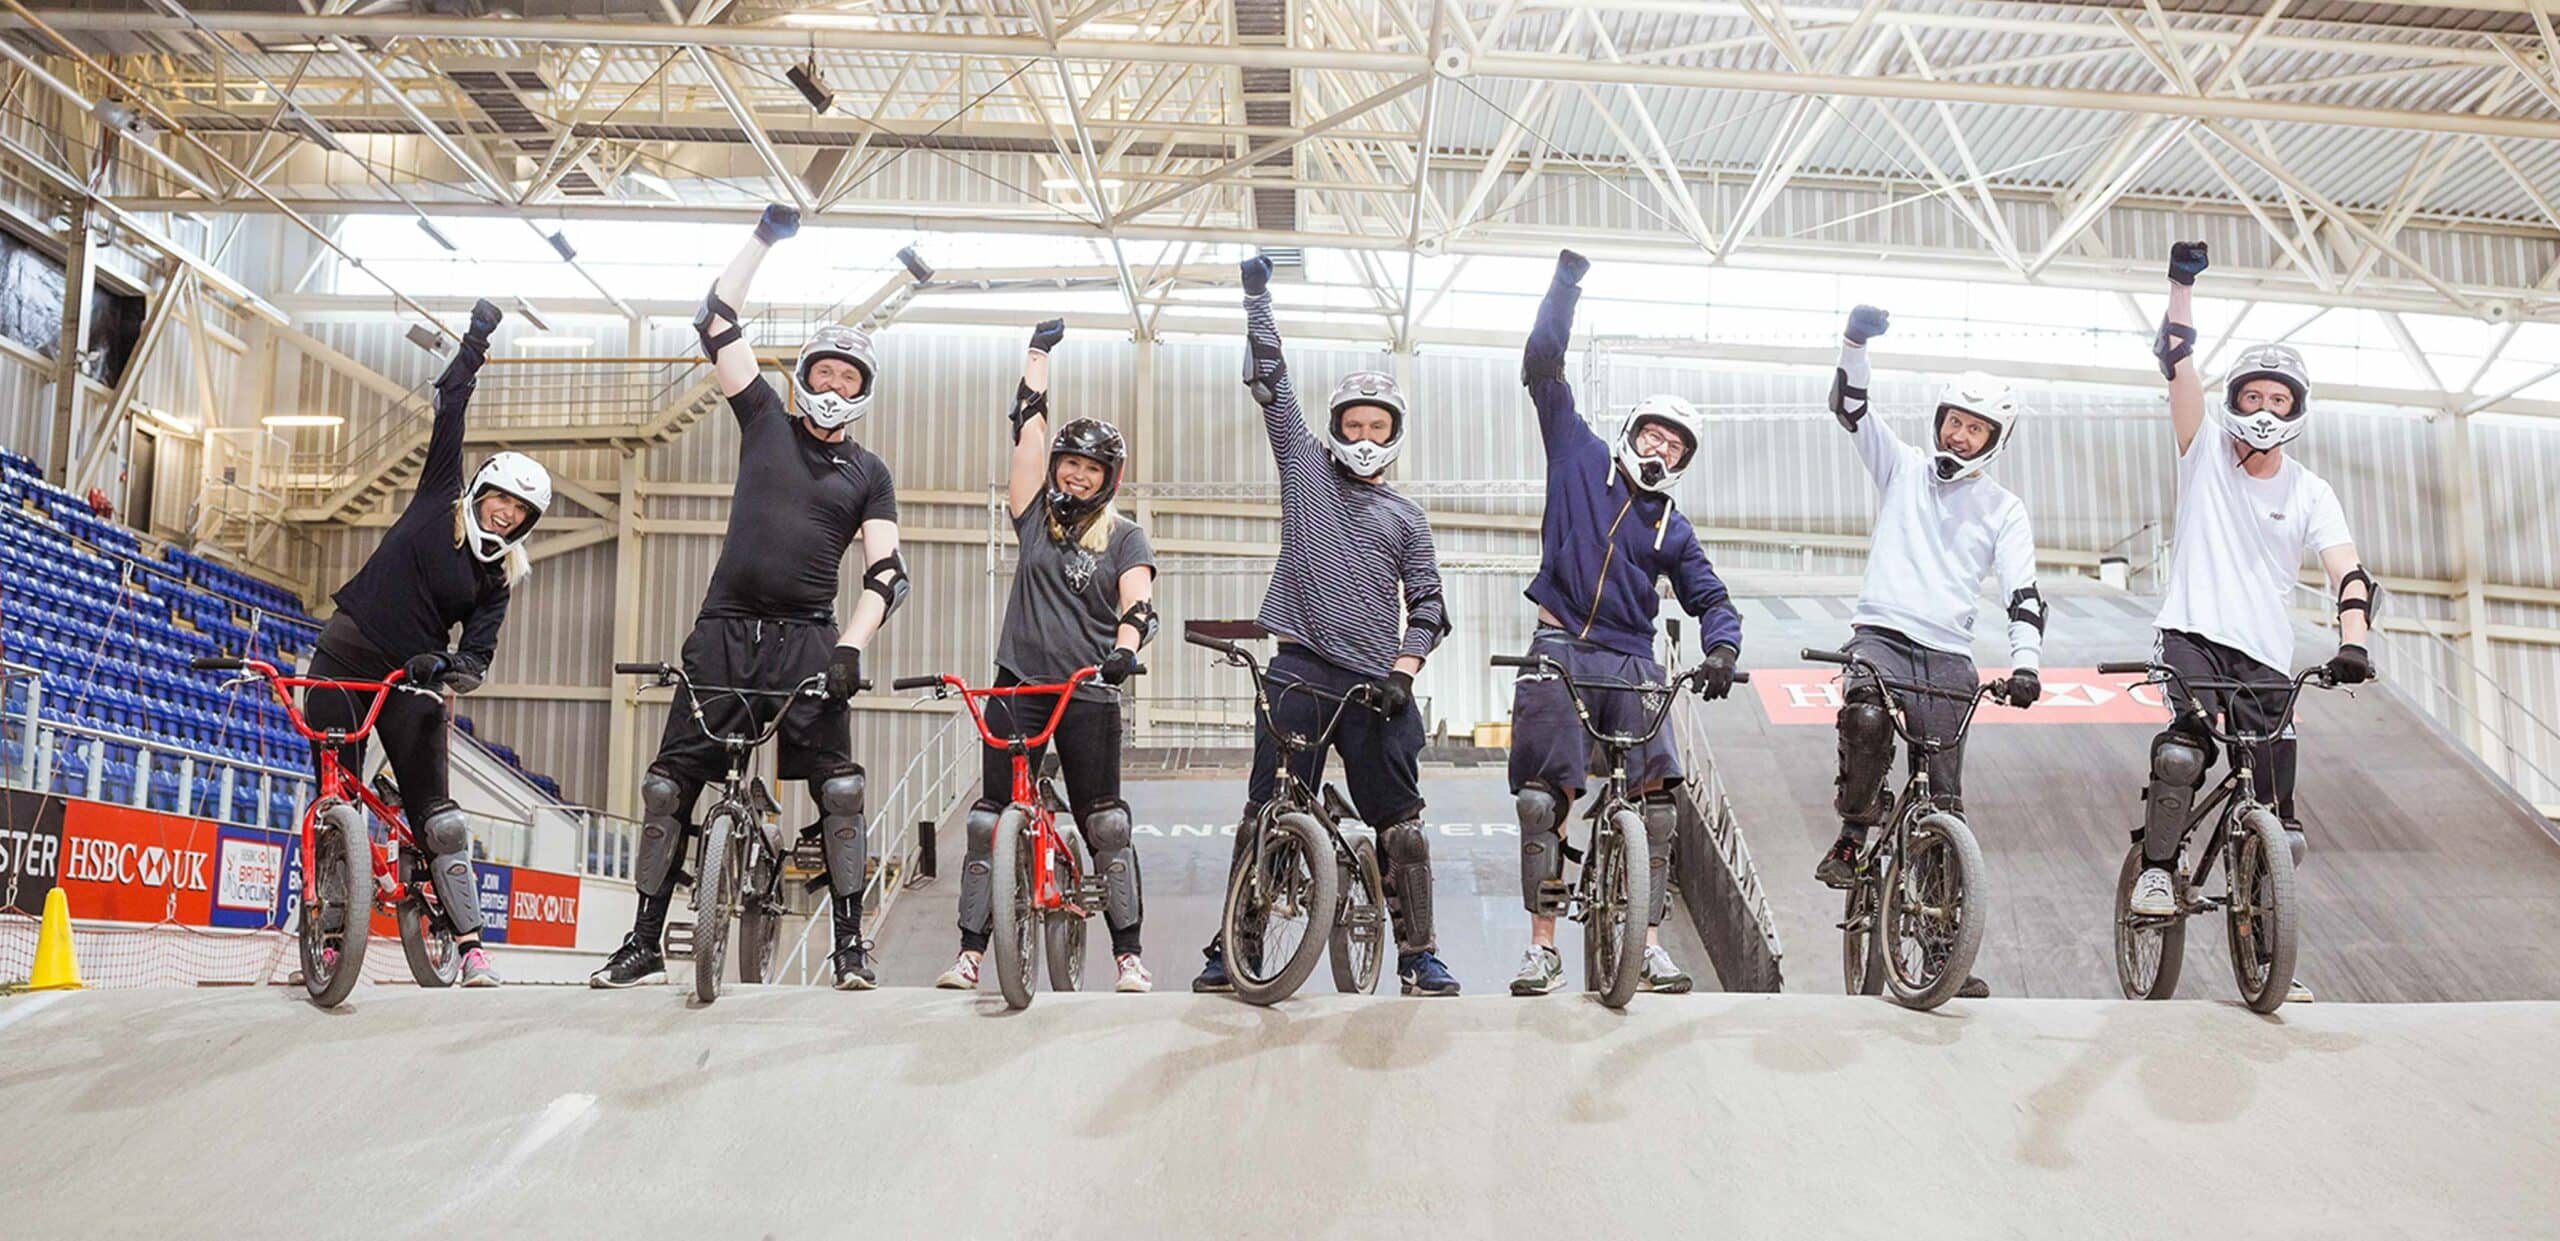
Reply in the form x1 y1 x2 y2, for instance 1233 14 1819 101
996 494 1155 701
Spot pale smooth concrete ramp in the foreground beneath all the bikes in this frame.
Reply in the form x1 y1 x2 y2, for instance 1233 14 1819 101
0 988 2560 1241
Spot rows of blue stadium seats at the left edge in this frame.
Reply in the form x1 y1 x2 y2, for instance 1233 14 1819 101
0 450 558 829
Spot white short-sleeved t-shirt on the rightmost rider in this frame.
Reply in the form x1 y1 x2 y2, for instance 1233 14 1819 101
2158 420 2355 673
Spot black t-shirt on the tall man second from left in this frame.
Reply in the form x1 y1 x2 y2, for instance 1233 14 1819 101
701 376 899 619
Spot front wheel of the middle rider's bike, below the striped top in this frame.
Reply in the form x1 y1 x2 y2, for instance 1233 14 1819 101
1219 814 1341 1003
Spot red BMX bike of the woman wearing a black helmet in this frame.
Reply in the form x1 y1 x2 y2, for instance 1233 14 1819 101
893 668 1144 1008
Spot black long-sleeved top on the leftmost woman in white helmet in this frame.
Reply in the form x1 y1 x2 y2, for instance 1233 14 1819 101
333 358 509 668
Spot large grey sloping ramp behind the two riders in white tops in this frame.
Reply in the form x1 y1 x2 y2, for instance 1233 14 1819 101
1708 589 2560 1013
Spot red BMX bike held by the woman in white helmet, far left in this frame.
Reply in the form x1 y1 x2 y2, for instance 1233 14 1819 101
189 655 463 1008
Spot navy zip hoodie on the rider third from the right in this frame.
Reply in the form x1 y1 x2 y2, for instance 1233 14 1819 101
1523 281 1743 658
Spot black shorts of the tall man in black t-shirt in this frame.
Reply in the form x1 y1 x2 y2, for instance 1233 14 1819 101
650 617 852 783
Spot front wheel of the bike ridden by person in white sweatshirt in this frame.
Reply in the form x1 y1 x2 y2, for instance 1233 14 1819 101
1874 814 1989 1011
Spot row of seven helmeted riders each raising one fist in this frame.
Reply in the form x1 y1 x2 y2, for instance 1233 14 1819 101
307 205 2373 1000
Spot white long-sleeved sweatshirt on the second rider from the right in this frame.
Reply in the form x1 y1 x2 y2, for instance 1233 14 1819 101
1830 343 2045 668
